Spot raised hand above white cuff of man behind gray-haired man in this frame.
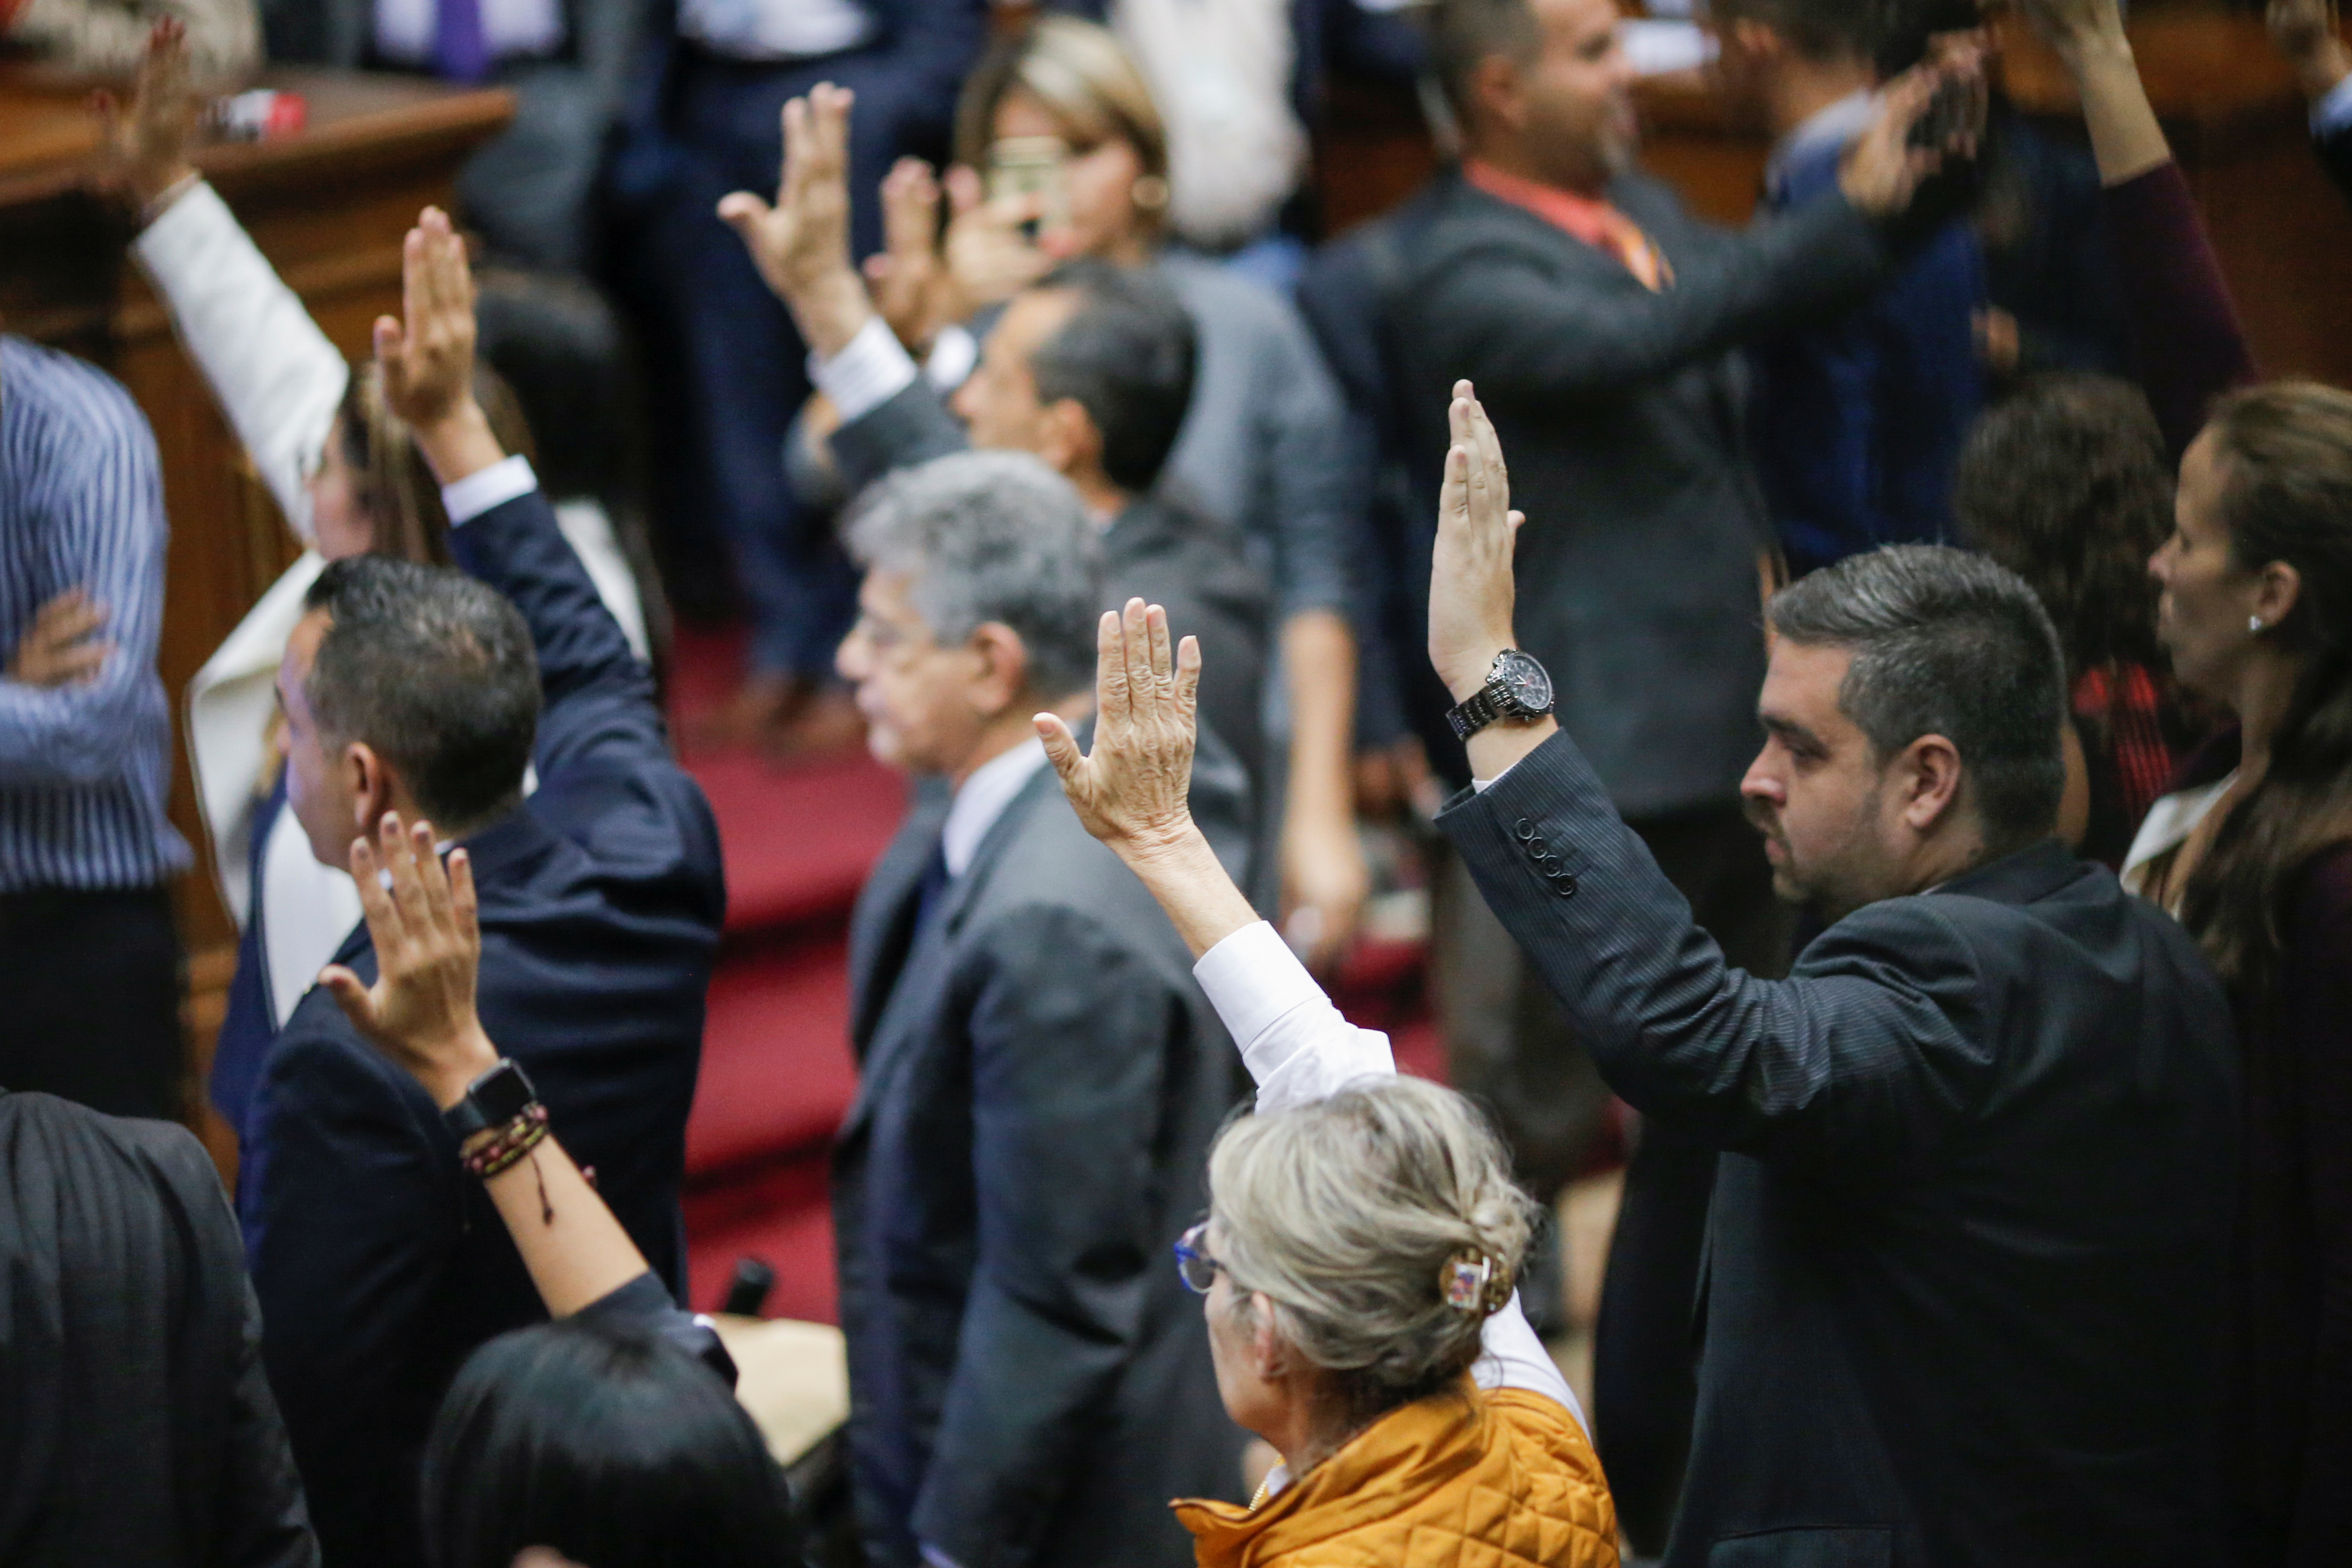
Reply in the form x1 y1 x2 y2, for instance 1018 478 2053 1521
720 82 872 357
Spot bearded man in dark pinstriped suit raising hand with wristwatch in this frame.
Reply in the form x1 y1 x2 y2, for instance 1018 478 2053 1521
1430 388 2237 1568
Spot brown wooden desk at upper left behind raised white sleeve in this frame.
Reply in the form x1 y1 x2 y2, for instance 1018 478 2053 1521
0 71 513 1168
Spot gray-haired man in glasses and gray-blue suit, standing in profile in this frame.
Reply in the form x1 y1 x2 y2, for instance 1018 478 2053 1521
833 452 1242 1568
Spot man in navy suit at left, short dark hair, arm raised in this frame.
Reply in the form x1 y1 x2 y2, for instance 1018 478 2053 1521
238 212 727 1568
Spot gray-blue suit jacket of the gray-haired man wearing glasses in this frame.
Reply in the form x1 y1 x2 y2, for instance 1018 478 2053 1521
833 766 1242 1568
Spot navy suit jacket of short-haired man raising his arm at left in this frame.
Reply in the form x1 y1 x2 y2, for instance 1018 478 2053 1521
238 491 727 1568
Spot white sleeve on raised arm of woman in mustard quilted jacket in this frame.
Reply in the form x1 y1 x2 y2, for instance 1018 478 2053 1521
1193 919 1397 1110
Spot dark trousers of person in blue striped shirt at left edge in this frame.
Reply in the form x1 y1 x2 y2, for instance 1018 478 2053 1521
0 889 181 1119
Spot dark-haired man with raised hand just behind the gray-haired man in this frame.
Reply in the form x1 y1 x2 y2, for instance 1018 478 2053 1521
731 92 1273 827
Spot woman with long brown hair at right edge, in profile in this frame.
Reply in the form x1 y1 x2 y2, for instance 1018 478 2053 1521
2124 381 2352 1568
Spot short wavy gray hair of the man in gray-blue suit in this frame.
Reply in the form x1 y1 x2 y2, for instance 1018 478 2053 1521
847 452 1103 698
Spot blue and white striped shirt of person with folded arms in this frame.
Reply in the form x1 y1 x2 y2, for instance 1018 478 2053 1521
0 336 188 893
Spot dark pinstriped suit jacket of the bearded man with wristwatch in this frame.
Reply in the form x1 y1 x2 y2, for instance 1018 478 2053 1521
1439 736 2237 1568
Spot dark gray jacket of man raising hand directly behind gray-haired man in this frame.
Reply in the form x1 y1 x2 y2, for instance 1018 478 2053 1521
830 376 1275 809
